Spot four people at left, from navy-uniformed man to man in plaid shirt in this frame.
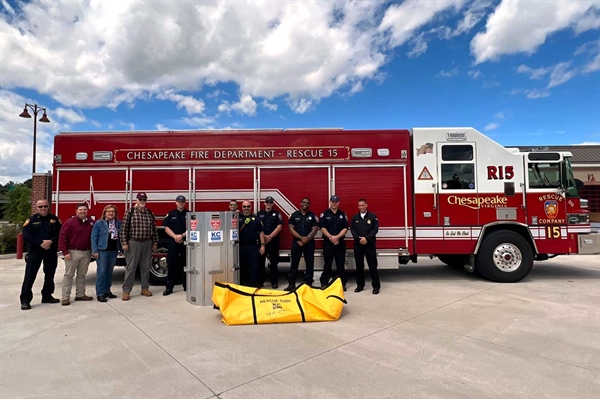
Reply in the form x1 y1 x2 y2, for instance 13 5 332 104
20 193 166 310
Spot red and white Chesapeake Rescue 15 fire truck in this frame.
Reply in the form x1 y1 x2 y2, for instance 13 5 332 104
52 128 600 283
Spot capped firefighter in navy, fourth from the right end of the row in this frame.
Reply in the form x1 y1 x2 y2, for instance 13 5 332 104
256 197 283 288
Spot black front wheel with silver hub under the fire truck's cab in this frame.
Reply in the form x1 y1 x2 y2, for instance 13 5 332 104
476 231 533 283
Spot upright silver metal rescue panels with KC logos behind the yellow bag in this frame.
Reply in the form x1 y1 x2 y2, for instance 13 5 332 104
185 212 239 306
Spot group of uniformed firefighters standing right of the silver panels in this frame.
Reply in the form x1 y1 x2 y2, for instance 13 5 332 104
234 195 381 295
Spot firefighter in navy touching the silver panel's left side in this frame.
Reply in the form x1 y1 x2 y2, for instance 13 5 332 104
163 195 189 296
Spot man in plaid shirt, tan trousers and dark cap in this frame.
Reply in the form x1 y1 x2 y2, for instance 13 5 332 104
119 193 158 301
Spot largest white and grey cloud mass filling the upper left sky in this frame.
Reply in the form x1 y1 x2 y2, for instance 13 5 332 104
0 0 390 115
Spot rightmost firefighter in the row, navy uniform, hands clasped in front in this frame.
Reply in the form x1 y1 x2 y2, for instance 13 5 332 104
350 198 381 295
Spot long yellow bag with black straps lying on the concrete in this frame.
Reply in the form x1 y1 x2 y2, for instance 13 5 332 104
212 278 347 325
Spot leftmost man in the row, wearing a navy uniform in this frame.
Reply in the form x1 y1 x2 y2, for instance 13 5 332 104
20 200 62 310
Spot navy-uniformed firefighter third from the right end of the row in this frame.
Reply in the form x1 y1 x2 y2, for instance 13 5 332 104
285 198 319 291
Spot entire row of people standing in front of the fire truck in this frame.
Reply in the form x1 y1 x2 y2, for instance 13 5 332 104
20 192 381 310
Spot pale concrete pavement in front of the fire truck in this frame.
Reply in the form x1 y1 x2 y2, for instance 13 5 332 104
0 256 600 399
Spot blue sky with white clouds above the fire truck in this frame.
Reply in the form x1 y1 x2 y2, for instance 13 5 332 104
0 0 600 184
